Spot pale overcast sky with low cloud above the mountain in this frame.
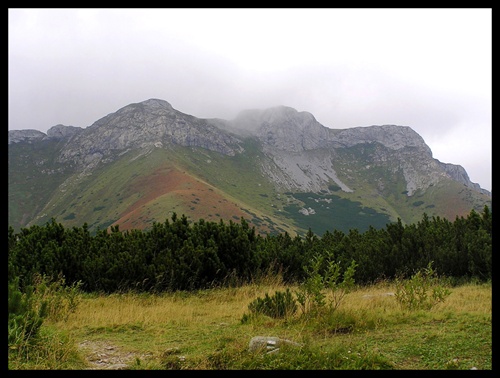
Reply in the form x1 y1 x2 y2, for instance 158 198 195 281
8 8 492 190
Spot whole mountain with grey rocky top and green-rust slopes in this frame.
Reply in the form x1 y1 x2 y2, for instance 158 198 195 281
8 99 491 235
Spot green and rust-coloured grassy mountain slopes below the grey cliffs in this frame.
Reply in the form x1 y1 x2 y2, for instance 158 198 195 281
9 138 491 235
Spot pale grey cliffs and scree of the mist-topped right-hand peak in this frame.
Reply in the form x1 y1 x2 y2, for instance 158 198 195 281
227 106 488 196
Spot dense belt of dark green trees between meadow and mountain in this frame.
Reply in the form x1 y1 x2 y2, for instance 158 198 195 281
8 206 492 293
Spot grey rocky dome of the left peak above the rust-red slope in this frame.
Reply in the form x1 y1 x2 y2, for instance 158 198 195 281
49 99 242 166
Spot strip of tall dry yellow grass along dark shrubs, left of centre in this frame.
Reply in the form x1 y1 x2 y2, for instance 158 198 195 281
61 270 285 329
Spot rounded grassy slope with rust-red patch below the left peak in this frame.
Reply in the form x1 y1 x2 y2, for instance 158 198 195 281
24 147 293 232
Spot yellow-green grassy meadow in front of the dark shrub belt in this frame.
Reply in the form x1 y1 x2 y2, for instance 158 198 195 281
9 277 492 370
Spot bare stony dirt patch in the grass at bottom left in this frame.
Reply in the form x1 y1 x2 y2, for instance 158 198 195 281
78 340 150 370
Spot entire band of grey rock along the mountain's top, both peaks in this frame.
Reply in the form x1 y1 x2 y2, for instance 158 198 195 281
9 99 490 196
